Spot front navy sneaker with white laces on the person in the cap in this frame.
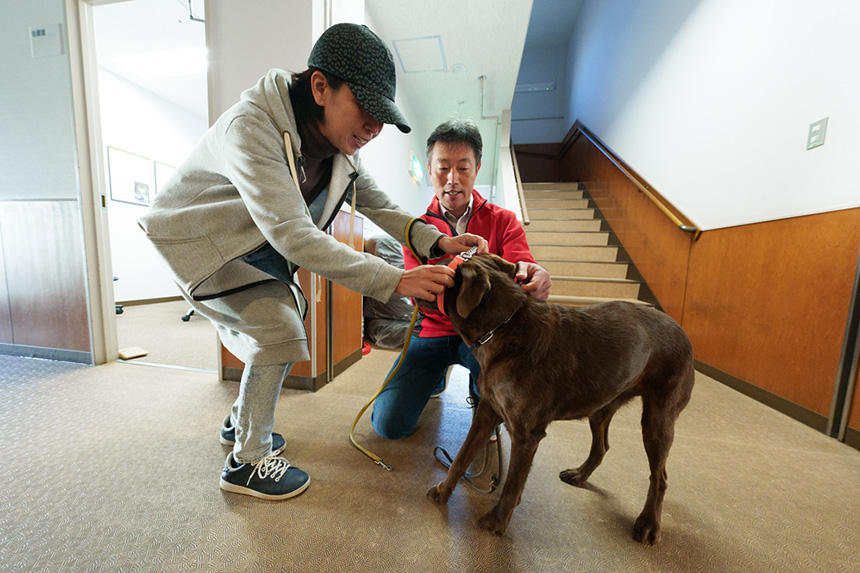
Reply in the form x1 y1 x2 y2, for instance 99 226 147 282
221 452 311 500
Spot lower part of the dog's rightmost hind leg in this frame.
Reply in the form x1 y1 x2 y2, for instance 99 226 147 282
633 396 678 545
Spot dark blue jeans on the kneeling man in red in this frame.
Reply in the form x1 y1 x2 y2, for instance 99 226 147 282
370 334 481 440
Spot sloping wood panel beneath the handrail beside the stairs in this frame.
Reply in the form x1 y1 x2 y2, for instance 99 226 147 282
561 137 693 322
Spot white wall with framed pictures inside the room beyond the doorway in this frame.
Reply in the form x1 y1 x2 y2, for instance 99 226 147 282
99 70 208 302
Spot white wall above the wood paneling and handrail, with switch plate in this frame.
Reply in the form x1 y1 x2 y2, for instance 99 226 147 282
567 0 860 229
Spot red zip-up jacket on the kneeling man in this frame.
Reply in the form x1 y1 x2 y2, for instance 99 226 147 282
403 189 536 338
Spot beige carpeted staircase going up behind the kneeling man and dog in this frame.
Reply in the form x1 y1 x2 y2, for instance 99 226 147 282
523 183 648 306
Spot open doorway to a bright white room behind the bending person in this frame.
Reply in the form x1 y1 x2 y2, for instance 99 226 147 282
89 0 217 371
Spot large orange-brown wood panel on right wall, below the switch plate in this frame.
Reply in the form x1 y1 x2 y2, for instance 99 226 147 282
683 209 860 417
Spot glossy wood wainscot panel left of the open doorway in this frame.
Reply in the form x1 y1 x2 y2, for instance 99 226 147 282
0 201 91 352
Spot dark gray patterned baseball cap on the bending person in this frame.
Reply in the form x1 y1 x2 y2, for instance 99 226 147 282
308 24 412 133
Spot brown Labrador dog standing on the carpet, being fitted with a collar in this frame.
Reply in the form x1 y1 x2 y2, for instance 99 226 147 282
427 255 693 544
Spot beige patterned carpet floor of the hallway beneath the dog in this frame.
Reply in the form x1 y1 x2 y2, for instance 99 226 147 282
0 340 860 572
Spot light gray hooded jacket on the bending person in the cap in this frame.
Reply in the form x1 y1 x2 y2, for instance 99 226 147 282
139 70 442 308
